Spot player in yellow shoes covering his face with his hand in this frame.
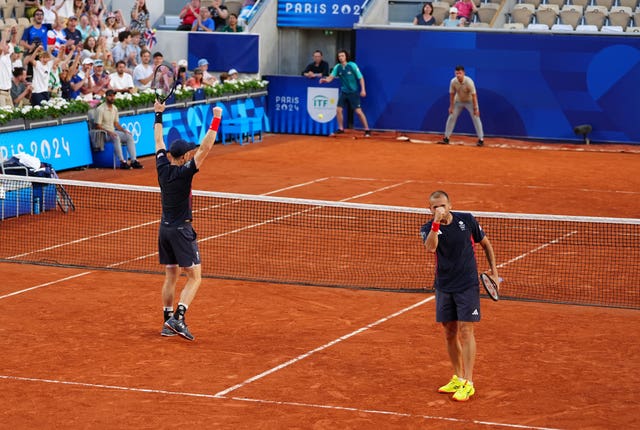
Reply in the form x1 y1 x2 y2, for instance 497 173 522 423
420 191 500 402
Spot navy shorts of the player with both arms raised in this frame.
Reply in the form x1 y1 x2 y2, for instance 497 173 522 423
158 223 200 267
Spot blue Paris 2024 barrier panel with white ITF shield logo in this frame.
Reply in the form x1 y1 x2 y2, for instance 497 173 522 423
265 76 340 136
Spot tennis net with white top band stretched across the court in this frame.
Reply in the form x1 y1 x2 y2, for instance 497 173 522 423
0 175 640 309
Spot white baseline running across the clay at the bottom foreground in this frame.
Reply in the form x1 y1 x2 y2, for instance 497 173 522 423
0 375 559 430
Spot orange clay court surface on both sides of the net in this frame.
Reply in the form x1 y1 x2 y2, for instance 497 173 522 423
0 133 640 429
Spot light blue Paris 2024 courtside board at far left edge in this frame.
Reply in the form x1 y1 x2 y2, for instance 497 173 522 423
0 122 93 171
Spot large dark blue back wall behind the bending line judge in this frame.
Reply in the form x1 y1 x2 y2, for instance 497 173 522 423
356 30 640 143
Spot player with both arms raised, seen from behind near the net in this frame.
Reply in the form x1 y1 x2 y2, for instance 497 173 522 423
153 101 222 340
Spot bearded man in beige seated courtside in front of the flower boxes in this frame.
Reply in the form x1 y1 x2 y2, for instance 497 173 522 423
96 90 142 169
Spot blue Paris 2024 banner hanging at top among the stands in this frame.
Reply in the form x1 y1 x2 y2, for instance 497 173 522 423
278 0 367 29
